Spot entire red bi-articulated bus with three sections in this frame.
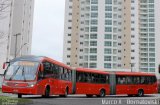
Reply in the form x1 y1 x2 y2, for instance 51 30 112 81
2 56 158 98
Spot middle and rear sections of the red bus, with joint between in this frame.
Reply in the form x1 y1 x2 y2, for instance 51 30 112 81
75 68 158 97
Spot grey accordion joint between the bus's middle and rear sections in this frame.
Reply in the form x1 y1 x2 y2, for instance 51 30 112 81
109 72 116 95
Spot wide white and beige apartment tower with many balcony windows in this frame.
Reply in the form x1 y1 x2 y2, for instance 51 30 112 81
63 0 160 76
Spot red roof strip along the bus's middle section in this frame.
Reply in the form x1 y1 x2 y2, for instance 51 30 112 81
76 68 109 74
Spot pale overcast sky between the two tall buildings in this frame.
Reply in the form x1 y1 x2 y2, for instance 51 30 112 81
32 0 65 61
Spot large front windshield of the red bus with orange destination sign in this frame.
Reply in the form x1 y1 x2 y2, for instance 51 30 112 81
5 61 39 81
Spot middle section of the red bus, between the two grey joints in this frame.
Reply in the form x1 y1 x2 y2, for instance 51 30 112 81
75 68 110 97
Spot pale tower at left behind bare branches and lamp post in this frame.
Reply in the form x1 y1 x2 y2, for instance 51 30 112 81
0 0 34 73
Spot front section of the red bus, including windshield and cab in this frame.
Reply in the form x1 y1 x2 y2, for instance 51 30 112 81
2 56 72 98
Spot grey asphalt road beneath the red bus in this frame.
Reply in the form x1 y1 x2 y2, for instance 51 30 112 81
23 94 160 105
